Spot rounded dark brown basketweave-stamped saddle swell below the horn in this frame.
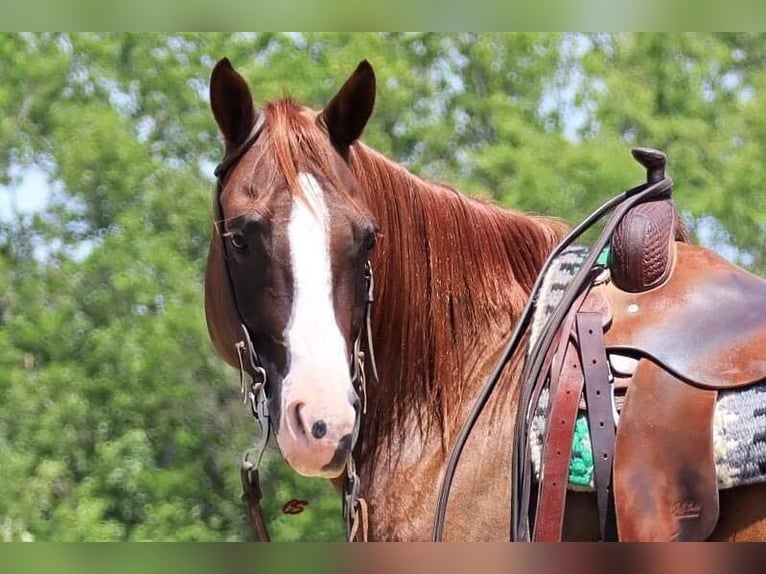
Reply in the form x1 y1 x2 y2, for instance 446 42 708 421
609 199 677 293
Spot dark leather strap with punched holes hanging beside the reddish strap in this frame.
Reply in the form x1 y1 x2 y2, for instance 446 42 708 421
577 311 616 540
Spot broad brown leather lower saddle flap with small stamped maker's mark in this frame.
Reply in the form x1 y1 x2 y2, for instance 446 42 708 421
614 360 718 541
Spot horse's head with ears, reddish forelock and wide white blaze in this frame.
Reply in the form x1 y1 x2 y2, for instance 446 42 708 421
205 59 378 478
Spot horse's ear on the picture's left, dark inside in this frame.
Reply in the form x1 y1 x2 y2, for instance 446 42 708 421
210 58 255 148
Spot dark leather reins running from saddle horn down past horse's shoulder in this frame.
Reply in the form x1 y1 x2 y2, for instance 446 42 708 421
432 148 672 542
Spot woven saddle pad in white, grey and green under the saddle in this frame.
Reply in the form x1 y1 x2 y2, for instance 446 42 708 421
530 246 766 490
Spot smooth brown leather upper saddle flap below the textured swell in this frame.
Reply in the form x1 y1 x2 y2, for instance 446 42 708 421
594 243 766 389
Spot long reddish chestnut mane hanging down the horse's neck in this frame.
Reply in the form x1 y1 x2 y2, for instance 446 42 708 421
350 144 564 464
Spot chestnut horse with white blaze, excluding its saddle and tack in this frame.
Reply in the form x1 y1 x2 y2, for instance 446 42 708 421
205 59 766 540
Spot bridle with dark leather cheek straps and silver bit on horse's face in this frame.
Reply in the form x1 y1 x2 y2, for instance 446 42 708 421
213 115 378 541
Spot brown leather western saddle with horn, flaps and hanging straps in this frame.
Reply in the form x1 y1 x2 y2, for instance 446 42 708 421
532 148 766 541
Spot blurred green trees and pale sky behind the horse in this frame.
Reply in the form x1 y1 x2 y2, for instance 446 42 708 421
0 33 766 541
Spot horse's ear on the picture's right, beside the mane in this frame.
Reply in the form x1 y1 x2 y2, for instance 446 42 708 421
320 60 375 157
